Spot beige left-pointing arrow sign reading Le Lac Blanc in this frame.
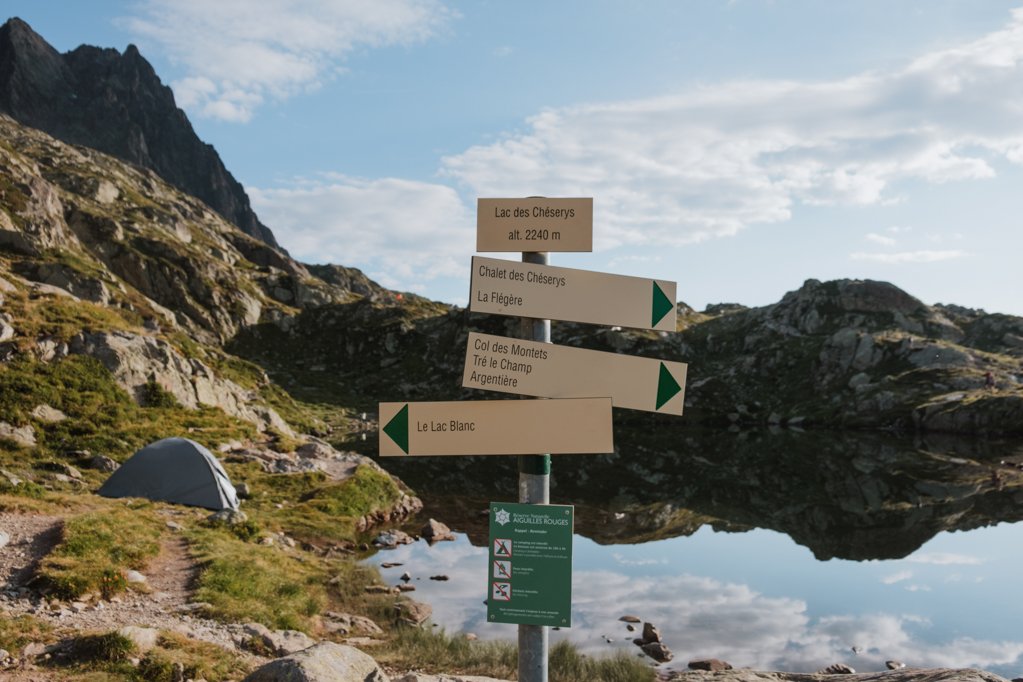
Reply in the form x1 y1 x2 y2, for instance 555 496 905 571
380 397 615 457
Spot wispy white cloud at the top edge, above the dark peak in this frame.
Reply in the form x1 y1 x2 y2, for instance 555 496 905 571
124 0 454 122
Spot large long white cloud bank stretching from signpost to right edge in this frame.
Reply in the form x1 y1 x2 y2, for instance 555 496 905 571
443 10 1023 252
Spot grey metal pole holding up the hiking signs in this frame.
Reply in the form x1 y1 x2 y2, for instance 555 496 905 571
519 252 550 682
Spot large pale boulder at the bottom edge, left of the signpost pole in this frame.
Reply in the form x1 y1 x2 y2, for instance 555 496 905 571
242 642 390 682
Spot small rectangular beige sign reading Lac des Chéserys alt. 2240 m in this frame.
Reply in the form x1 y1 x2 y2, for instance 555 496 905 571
476 197 593 252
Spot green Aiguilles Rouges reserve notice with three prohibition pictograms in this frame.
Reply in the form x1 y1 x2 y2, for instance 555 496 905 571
487 502 574 628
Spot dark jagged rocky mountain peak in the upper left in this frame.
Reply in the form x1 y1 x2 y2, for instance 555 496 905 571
0 18 277 247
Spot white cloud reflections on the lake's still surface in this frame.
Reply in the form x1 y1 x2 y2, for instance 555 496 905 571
364 536 1023 672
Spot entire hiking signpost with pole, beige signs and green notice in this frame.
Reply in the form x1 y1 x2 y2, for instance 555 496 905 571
380 197 686 682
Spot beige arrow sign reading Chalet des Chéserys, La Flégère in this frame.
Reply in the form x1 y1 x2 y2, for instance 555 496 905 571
469 256 675 331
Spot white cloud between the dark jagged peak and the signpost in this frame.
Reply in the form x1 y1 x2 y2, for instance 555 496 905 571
249 175 475 290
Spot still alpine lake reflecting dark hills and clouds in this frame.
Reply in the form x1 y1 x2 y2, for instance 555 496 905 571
353 427 1023 679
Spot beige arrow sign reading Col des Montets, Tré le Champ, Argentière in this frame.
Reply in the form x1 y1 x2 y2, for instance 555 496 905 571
461 332 686 414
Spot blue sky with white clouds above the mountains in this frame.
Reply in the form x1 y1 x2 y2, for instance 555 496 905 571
4 0 1023 315
